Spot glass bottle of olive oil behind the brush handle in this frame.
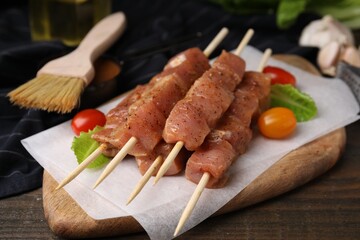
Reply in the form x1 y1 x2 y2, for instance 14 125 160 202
29 0 111 46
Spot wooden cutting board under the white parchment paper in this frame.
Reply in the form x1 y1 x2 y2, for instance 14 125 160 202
43 55 346 238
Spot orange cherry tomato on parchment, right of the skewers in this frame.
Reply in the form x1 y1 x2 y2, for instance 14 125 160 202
258 107 296 139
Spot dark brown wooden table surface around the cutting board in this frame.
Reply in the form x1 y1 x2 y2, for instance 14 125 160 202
0 121 360 240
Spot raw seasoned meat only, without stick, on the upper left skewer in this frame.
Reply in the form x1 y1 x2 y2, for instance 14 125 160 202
98 48 210 156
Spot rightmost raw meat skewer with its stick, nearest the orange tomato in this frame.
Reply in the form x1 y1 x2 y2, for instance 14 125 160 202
174 49 271 236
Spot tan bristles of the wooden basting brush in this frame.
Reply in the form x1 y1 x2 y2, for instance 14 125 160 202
8 74 85 113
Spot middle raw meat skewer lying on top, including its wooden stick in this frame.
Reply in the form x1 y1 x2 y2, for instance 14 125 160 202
155 29 253 183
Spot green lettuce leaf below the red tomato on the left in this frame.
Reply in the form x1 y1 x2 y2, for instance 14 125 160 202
71 126 109 168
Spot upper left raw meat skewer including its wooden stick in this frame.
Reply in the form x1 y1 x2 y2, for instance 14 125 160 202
94 28 228 188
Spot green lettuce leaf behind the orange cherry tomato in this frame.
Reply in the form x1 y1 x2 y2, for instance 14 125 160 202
270 84 317 122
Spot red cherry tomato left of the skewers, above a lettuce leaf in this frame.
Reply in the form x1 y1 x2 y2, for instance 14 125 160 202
71 109 106 135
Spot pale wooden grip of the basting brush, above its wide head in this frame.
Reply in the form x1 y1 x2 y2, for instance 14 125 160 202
73 12 126 62
